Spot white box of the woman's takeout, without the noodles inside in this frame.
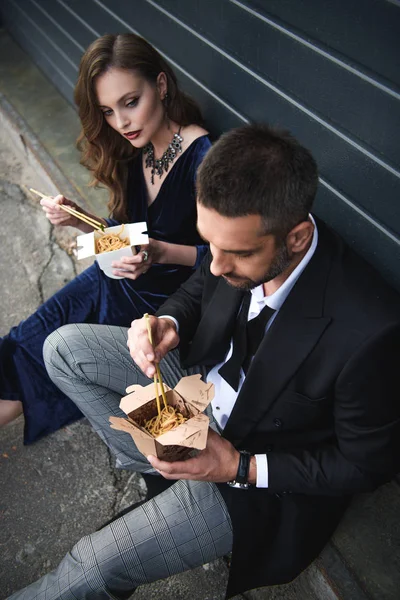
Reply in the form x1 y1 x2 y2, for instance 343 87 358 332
76 221 149 279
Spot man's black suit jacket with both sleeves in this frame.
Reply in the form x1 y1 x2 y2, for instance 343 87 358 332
158 220 400 595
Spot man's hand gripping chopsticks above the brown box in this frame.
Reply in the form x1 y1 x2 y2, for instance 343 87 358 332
127 316 179 378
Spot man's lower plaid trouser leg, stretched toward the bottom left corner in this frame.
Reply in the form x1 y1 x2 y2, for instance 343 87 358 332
9 481 232 600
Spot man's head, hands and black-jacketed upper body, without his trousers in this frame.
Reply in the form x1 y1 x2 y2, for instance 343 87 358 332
132 126 400 590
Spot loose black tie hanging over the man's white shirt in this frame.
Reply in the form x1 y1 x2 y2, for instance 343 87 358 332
218 292 275 392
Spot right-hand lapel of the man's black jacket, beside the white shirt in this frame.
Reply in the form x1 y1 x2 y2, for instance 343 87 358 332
224 224 332 445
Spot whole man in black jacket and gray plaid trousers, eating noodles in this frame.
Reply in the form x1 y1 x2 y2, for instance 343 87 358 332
11 125 400 598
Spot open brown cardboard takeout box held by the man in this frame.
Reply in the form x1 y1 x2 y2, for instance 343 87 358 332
110 375 214 462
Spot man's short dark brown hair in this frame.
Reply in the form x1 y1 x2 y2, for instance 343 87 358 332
197 124 318 240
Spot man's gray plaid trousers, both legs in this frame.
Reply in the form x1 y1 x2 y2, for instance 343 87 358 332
9 325 232 600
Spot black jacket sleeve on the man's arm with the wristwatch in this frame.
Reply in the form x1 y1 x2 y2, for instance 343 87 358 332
268 325 400 495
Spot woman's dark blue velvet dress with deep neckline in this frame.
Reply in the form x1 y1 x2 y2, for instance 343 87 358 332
0 136 210 444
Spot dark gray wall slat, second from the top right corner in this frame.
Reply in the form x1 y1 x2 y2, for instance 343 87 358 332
158 0 400 166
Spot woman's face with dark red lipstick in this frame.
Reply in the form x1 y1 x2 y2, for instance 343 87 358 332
95 67 167 148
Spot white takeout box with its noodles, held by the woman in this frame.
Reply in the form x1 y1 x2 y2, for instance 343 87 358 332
77 221 149 279
